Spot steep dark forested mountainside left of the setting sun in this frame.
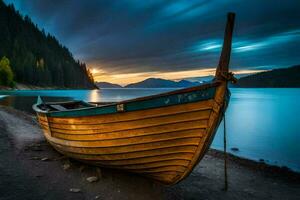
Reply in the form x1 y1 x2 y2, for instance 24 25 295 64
0 0 95 88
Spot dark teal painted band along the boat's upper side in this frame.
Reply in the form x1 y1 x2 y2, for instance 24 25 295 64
47 87 216 117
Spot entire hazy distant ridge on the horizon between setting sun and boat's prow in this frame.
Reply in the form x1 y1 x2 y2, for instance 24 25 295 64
96 78 200 88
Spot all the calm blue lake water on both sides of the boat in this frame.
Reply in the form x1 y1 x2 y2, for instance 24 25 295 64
0 89 300 171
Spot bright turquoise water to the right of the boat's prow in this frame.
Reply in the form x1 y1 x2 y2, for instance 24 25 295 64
213 89 300 171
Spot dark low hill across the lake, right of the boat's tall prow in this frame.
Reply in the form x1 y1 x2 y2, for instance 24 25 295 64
233 65 300 88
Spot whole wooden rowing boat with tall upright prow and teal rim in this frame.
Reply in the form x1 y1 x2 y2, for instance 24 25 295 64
33 13 234 184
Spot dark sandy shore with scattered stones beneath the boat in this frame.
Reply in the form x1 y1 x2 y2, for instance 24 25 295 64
0 107 300 200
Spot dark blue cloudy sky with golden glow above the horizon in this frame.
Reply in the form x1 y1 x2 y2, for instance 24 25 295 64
5 0 300 83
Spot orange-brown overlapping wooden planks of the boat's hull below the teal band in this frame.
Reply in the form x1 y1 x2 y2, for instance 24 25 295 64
34 84 226 184
